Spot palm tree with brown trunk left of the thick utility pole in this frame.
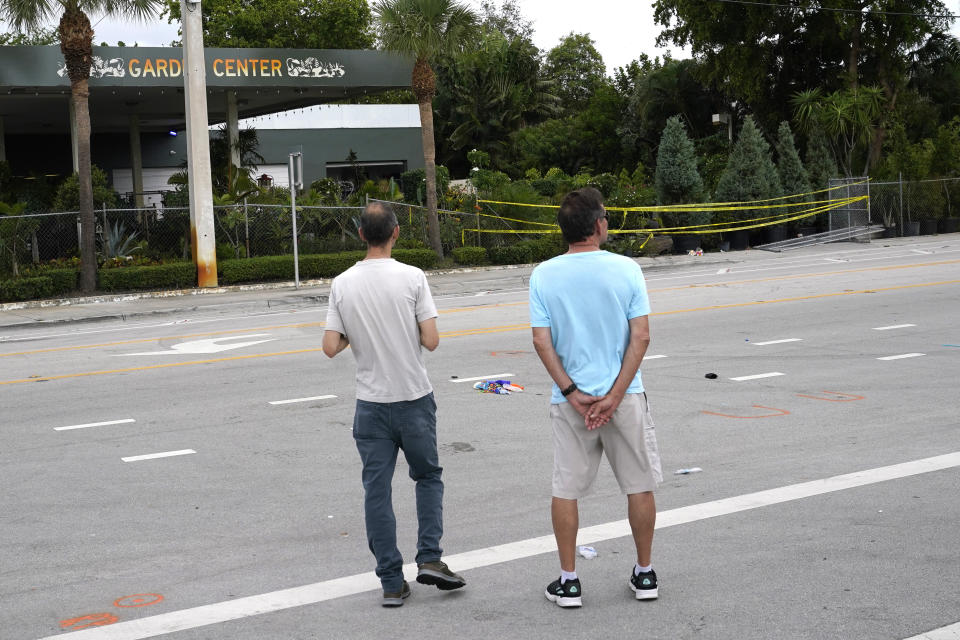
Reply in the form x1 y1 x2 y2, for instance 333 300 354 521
0 0 165 293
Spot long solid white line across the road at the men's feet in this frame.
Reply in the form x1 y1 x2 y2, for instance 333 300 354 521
41 451 960 640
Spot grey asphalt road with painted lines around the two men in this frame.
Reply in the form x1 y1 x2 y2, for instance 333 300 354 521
0 235 960 640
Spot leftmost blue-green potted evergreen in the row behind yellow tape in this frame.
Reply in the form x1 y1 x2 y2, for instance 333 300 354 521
654 116 709 227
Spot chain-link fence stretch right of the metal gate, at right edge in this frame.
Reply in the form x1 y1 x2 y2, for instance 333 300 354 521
870 178 960 236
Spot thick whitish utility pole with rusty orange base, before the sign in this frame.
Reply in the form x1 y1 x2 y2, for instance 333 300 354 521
180 0 217 287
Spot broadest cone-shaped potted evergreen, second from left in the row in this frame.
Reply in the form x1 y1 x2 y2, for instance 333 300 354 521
714 116 783 220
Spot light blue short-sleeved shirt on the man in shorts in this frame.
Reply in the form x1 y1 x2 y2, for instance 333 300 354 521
530 251 650 404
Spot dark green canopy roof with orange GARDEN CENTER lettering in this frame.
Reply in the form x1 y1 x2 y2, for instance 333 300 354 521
0 46 413 136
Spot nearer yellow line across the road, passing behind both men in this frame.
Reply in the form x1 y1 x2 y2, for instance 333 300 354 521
0 280 960 386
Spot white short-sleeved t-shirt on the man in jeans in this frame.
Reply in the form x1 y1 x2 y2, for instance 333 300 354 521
325 258 437 402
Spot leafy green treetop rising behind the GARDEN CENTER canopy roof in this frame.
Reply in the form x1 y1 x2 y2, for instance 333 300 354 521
163 0 373 49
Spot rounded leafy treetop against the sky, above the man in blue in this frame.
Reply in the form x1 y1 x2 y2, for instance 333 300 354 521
543 32 606 115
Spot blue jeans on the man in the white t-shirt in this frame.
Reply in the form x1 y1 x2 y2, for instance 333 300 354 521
353 393 443 592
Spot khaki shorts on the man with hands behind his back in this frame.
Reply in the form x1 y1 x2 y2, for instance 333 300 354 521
550 393 663 500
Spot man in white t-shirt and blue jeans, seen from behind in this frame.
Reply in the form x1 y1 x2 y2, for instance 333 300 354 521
323 202 466 607
